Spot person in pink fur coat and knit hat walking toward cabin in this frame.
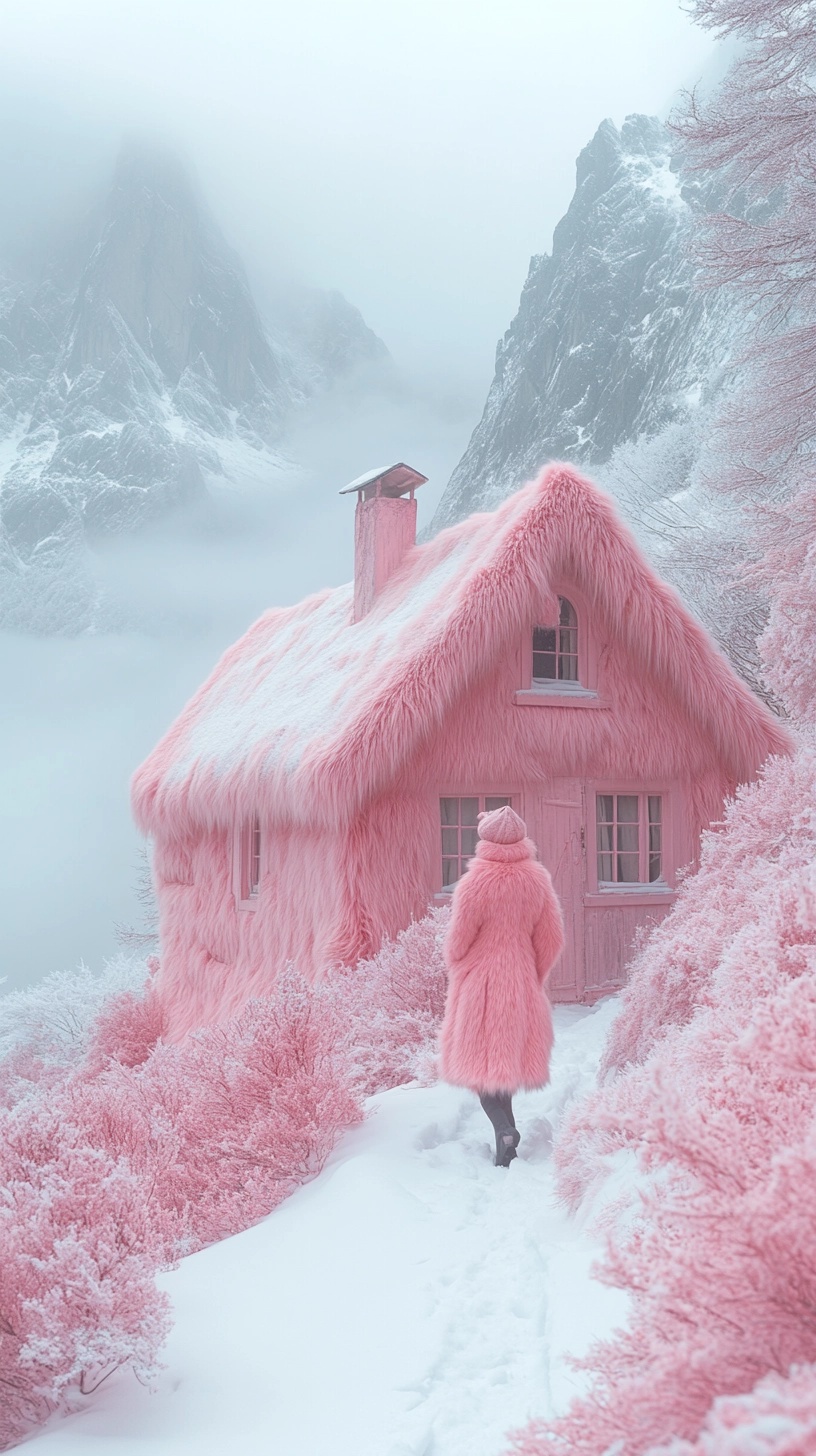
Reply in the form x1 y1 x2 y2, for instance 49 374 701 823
440 805 564 1168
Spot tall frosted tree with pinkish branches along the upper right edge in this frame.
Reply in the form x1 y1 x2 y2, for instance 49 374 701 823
676 0 816 721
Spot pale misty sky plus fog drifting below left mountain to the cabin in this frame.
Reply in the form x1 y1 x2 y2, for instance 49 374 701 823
0 0 713 989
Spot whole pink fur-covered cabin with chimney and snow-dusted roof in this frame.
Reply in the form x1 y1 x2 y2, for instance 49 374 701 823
133 464 788 1037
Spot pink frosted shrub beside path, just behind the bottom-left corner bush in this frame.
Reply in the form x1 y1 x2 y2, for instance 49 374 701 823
68 968 361 1249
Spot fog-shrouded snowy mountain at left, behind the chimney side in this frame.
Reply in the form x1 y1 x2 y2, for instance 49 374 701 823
0 144 388 625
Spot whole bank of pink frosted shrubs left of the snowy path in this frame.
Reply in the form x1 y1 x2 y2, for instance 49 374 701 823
0 910 447 1444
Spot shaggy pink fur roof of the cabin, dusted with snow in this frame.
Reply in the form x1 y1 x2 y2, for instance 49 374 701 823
133 464 790 834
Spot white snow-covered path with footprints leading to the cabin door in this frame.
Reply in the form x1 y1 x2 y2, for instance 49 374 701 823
26 1003 622 1456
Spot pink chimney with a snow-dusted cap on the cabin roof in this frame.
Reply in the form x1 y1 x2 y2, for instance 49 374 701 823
340 460 427 622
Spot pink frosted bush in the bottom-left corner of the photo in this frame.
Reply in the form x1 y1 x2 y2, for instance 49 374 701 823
0 1104 169 1447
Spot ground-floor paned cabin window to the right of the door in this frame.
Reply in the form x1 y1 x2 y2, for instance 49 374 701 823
595 794 663 890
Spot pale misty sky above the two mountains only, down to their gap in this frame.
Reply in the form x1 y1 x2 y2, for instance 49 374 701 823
0 0 711 402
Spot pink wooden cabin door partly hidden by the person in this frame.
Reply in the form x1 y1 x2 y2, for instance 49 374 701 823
525 779 584 1002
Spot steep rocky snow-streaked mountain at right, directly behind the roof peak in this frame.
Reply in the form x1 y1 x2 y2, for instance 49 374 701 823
433 115 737 530
